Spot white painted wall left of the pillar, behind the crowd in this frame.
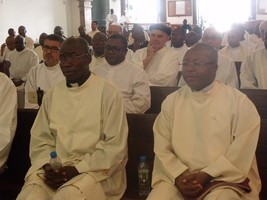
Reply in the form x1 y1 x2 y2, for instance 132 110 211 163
0 0 79 44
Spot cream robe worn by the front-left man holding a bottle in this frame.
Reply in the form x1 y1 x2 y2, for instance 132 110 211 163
22 74 128 199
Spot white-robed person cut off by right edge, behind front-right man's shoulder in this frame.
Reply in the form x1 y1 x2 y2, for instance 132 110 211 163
240 30 267 89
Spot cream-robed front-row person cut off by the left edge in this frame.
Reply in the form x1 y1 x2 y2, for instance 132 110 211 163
0 72 17 174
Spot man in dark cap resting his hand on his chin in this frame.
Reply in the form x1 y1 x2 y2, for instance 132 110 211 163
131 24 179 86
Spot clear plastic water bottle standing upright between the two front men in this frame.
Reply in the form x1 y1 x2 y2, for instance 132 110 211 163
138 156 150 198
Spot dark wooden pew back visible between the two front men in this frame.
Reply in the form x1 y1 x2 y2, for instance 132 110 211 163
123 114 157 200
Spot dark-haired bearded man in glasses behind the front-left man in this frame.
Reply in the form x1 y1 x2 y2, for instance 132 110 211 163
25 34 64 109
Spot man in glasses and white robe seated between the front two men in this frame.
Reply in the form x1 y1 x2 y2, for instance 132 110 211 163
93 34 150 113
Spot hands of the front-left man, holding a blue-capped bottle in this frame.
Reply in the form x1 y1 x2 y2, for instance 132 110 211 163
43 163 79 189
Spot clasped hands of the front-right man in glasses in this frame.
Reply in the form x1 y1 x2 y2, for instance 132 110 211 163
175 171 213 197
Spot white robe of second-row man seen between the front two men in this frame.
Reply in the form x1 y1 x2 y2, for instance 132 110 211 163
93 60 151 113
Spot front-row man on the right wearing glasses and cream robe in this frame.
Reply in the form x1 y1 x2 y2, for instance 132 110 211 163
147 43 261 200
